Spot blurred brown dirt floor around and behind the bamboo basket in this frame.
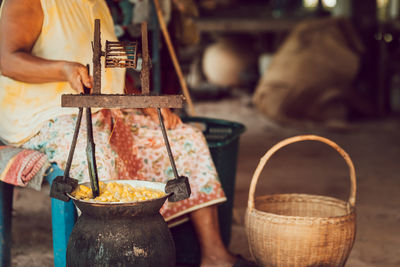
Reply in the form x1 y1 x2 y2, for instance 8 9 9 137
12 97 400 267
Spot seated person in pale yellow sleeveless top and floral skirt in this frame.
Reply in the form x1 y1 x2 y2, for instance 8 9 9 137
0 0 255 266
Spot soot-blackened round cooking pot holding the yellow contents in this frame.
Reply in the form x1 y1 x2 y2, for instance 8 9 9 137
67 180 175 267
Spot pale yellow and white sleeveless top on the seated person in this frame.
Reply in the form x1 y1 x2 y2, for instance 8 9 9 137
0 0 125 145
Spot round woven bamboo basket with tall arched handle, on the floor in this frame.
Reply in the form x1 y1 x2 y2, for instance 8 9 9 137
245 135 356 267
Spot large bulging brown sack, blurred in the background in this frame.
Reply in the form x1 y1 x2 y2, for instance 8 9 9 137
253 18 364 122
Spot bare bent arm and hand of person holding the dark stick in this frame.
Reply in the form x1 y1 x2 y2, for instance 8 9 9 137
0 0 92 92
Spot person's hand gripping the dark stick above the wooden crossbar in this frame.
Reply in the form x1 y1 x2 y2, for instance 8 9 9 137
63 62 92 93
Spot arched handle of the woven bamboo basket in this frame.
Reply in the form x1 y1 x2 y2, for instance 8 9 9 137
247 135 357 211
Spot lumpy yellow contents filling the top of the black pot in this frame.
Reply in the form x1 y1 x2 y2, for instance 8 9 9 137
71 182 165 202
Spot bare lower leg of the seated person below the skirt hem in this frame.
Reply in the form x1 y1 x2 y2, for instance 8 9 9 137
190 205 237 267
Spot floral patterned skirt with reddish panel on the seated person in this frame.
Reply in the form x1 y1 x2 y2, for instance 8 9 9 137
23 109 226 223
